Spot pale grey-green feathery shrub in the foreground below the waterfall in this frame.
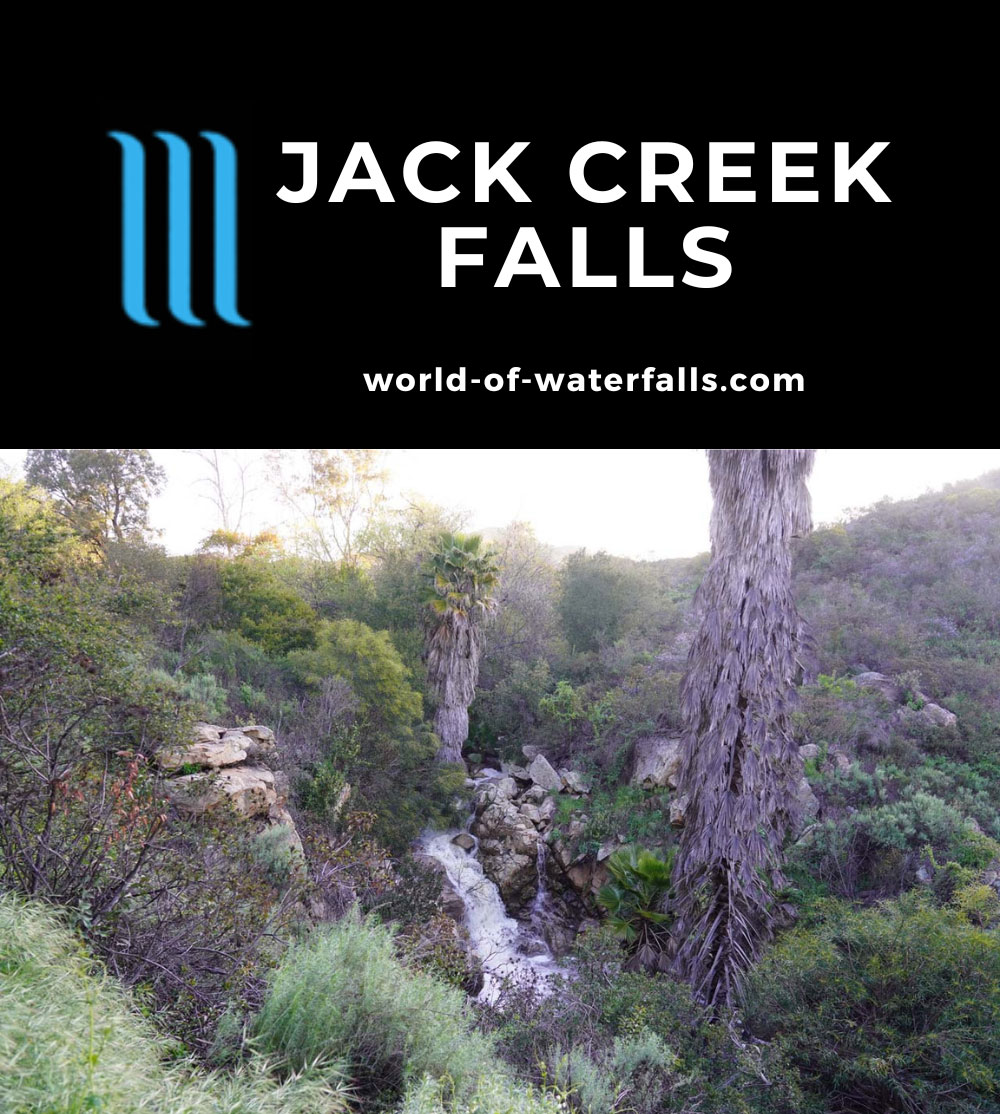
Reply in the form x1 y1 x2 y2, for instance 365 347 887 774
254 915 494 1097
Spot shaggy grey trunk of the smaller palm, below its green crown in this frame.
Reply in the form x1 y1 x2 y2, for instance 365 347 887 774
428 615 482 762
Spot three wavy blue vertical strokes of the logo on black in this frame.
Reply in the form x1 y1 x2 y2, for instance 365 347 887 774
108 131 251 326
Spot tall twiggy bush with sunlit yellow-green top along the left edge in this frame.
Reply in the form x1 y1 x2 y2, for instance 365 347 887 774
0 482 171 916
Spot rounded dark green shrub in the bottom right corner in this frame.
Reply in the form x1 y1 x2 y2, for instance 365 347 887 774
746 893 1000 1114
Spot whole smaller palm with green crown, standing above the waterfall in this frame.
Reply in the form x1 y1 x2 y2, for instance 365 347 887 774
425 534 500 762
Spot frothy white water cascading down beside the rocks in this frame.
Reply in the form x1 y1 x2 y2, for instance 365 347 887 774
420 830 565 1003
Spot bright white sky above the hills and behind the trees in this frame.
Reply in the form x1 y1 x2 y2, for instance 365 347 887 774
0 449 1000 558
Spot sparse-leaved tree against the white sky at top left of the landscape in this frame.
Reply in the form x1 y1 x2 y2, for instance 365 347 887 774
24 449 166 545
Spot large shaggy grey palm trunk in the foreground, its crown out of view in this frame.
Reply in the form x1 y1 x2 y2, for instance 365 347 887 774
673 449 815 1004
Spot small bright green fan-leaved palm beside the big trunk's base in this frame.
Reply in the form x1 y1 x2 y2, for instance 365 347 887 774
597 844 674 970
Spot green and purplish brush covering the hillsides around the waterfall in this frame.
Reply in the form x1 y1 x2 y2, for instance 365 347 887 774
0 450 1000 1114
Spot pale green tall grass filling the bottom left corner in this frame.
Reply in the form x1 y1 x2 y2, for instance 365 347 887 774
0 895 347 1114
